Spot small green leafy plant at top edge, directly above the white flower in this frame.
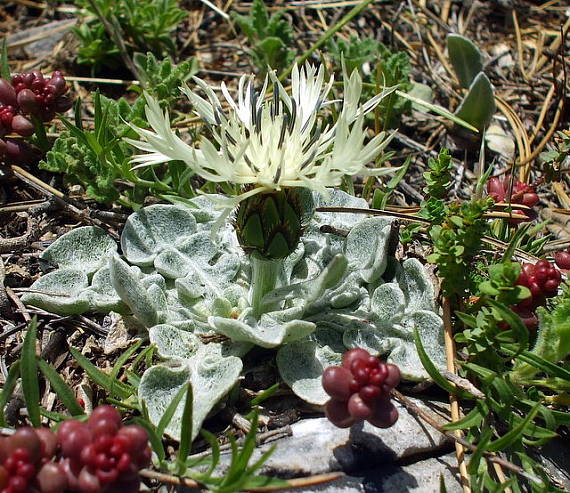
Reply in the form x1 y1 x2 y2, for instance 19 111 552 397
232 0 296 74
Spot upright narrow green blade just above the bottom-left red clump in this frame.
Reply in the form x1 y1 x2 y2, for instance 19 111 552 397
20 317 41 427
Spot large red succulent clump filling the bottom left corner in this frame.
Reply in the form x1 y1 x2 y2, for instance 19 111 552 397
0 406 151 493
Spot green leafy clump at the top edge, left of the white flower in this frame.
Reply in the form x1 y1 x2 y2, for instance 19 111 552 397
74 0 186 73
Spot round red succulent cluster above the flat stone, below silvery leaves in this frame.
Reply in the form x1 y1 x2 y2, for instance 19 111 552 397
322 348 400 428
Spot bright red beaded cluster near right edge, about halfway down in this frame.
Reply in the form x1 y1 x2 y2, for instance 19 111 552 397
513 260 562 328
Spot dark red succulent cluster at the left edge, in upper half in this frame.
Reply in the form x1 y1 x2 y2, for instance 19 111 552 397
0 70 73 161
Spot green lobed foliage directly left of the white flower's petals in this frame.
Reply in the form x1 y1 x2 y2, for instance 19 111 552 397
40 54 196 209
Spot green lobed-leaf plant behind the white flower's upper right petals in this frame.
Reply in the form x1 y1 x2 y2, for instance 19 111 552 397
328 36 412 128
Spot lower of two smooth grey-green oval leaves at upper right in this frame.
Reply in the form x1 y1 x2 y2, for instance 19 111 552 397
455 72 496 131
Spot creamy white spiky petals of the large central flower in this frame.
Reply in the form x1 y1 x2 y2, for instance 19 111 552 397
129 64 397 207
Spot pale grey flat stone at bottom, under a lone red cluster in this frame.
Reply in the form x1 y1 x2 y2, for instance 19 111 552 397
181 399 452 493
